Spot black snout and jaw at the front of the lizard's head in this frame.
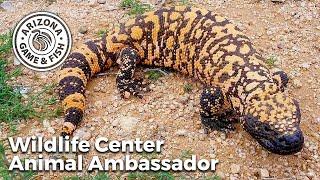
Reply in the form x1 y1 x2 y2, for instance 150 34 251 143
243 116 304 155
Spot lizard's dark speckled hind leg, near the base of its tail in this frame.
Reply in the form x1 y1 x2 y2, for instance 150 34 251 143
116 48 146 98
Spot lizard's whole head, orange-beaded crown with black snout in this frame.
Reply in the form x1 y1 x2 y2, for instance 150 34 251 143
243 92 304 155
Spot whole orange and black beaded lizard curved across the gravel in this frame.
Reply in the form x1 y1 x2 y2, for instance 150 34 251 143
58 6 304 154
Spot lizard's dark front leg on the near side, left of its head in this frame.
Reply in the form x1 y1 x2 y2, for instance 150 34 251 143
200 87 235 133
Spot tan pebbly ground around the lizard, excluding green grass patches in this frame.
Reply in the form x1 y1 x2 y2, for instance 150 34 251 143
0 0 320 179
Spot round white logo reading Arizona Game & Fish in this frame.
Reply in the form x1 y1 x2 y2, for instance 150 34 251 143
13 11 72 71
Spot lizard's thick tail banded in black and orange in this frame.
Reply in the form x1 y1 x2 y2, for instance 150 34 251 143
58 36 112 136
